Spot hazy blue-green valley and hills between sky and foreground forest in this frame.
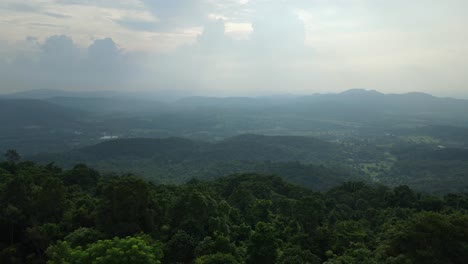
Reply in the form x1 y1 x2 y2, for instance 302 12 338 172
0 90 468 194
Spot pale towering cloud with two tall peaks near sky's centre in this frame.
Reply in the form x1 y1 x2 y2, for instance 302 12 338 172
144 5 314 94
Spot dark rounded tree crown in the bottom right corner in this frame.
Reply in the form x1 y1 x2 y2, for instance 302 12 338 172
379 212 468 264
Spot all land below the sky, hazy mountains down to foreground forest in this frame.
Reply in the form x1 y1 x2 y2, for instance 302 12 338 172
0 90 468 264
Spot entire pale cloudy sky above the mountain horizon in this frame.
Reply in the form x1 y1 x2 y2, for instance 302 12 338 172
0 0 468 98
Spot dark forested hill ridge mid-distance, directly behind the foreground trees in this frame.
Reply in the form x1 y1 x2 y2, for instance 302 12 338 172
32 135 358 189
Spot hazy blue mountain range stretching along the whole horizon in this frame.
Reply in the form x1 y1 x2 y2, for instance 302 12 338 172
4 89 468 126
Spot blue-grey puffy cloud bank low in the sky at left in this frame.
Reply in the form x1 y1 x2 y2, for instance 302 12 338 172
0 35 143 89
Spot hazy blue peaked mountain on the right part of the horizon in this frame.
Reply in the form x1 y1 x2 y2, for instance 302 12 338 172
291 89 468 126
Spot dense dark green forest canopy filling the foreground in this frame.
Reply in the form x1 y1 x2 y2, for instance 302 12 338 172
0 160 468 264
